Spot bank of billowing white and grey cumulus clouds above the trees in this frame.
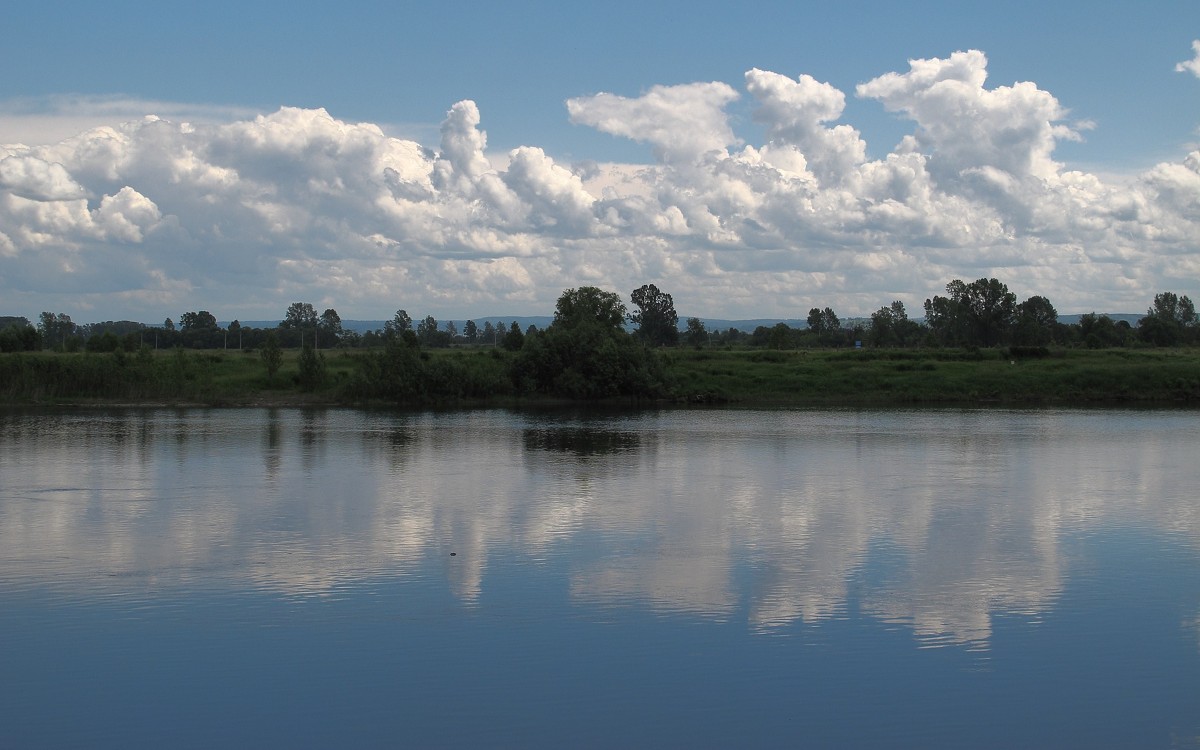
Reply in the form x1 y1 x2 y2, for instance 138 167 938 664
0 43 1200 320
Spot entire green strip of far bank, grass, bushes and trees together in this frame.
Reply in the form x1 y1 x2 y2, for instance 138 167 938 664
0 280 1200 407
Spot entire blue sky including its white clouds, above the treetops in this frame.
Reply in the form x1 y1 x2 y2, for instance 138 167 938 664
0 0 1200 323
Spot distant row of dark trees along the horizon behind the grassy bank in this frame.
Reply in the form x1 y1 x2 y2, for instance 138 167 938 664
0 278 1200 352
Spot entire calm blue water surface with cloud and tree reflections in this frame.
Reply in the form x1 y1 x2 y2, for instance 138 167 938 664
0 409 1200 748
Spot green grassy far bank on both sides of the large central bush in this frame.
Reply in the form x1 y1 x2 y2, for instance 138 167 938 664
0 348 1200 406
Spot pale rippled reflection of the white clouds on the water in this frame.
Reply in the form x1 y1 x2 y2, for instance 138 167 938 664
0 409 1200 646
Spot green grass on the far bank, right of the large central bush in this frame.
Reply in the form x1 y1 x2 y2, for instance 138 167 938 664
666 349 1200 404
